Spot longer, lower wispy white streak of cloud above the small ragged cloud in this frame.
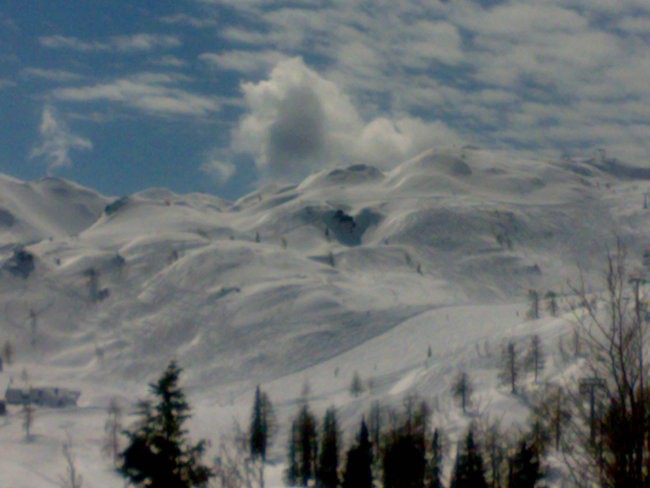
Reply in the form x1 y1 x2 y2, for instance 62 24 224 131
52 73 220 117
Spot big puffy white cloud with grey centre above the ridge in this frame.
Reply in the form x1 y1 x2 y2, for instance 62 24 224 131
233 58 461 180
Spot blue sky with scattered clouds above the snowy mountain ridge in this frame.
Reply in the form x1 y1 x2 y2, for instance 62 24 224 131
0 0 650 199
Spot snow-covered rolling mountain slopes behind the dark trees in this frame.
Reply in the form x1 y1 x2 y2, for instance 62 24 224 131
0 148 650 488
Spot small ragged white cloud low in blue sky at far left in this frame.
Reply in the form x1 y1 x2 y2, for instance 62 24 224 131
30 105 93 169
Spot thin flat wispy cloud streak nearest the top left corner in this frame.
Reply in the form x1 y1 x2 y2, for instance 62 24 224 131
39 34 182 53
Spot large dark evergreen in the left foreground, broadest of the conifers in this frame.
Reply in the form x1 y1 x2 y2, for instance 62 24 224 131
119 361 214 488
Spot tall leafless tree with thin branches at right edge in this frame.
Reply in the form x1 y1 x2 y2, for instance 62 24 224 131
564 239 650 487
